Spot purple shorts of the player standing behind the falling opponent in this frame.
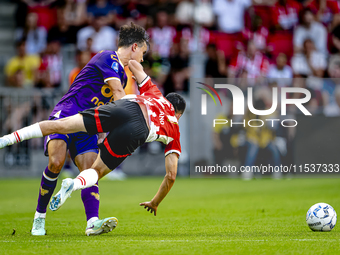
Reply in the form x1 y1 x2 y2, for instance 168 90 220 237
44 117 99 160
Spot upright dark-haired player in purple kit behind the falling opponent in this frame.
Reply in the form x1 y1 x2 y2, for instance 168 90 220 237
29 23 149 236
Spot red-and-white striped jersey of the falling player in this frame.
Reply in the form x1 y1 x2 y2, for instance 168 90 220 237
122 77 181 156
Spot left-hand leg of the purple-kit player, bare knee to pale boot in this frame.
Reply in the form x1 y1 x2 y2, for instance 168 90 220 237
31 139 67 235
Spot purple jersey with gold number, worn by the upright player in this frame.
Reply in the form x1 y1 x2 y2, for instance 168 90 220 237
50 50 127 118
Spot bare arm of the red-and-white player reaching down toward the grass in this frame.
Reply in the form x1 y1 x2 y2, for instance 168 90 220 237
139 153 178 216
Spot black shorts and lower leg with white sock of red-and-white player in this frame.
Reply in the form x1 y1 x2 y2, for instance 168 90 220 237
50 100 149 210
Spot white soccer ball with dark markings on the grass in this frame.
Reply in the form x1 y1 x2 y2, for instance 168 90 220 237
306 203 336 231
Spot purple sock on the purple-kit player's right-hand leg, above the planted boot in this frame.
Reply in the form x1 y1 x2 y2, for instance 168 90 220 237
81 182 99 220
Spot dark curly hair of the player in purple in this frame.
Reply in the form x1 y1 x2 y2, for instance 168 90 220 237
118 22 150 48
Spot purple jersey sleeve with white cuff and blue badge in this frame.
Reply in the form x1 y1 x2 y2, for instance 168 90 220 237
96 52 121 83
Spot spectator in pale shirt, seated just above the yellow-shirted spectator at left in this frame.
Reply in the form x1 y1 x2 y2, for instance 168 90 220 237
15 13 47 54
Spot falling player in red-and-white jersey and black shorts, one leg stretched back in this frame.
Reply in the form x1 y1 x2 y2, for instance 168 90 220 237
0 60 186 227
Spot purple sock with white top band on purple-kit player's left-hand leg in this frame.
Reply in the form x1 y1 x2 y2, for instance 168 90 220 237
37 167 59 213
